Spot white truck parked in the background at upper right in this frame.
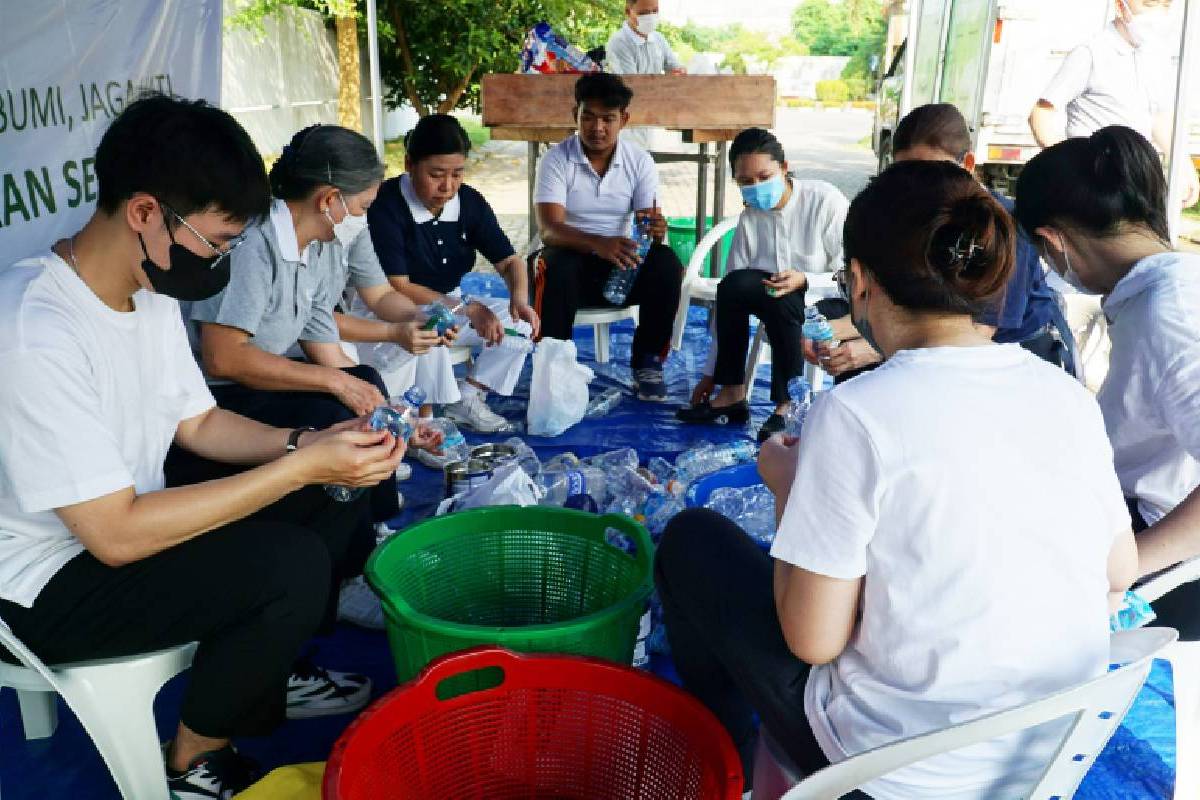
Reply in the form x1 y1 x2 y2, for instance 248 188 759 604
872 0 1113 193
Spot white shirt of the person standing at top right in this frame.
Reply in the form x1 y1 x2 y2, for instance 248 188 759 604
1042 24 1175 139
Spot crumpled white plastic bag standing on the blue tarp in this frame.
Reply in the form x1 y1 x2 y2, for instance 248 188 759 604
528 338 595 437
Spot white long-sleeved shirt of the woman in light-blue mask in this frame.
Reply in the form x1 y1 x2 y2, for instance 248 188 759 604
704 178 850 375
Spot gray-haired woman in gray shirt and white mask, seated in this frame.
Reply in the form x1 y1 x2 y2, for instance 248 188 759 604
180 125 431 525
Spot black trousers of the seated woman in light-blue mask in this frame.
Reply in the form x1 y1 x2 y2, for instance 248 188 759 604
713 270 804 403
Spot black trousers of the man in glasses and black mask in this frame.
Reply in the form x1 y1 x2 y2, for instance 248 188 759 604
0 487 366 738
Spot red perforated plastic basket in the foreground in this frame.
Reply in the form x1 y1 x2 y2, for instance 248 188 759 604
323 648 742 800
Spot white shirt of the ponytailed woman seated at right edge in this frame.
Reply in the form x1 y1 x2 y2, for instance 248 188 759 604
1098 253 1200 525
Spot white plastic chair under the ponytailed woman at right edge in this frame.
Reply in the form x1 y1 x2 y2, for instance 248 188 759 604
1135 558 1200 800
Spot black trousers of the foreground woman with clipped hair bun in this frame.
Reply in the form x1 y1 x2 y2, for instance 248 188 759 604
654 509 868 798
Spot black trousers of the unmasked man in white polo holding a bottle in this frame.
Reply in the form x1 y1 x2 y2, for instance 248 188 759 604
530 245 683 367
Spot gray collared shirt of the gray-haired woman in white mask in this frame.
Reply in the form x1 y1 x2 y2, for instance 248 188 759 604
191 200 343 367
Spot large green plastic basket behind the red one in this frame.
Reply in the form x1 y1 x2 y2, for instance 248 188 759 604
365 506 654 682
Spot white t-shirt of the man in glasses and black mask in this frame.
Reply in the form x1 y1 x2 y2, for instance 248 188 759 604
0 253 214 607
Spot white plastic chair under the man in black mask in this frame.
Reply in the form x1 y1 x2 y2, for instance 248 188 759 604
0 620 196 800
